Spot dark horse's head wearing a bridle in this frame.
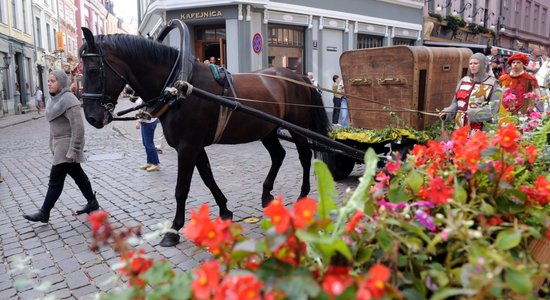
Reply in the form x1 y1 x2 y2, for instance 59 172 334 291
80 27 127 128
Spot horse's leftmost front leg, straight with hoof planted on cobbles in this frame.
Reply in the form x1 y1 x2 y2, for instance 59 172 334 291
160 147 204 247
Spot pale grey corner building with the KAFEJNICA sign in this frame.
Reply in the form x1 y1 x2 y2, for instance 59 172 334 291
139 0 424 108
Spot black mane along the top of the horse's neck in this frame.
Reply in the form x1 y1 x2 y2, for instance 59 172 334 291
78 34 178 64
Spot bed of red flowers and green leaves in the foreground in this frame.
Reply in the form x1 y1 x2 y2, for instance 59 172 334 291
90 116 550 299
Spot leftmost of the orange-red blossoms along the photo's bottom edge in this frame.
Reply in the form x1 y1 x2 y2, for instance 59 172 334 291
191 260 220 299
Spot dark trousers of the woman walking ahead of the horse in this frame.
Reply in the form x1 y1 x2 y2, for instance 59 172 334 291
42 163 95 212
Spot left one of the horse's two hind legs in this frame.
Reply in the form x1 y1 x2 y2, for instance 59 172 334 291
262 131 286 207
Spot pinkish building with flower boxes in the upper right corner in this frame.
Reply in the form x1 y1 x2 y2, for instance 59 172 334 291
424 0 550 52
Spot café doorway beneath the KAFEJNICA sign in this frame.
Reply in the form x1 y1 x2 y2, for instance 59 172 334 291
195 25 227 67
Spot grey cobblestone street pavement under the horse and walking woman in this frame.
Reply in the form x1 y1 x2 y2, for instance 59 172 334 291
0 100 362 299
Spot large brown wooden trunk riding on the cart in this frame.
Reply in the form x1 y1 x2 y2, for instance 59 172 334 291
340 46 473 130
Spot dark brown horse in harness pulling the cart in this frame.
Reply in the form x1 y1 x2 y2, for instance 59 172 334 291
79 27 331 247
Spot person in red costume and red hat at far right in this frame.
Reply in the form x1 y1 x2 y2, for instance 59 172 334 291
498 52 544 123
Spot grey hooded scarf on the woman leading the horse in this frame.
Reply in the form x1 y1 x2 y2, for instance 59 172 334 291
46 70 80 122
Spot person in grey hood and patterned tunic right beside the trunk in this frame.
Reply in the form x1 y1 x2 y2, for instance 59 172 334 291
439 53 501 130
